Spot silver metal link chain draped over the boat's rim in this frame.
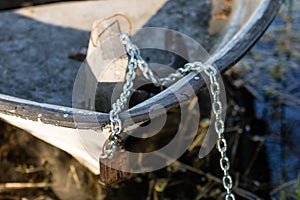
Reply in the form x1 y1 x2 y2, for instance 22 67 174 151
100 33 235 200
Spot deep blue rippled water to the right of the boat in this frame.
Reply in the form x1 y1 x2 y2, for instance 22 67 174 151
232 0 300 198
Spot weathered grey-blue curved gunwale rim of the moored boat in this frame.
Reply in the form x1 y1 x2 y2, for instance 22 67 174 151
0 0 282 129
